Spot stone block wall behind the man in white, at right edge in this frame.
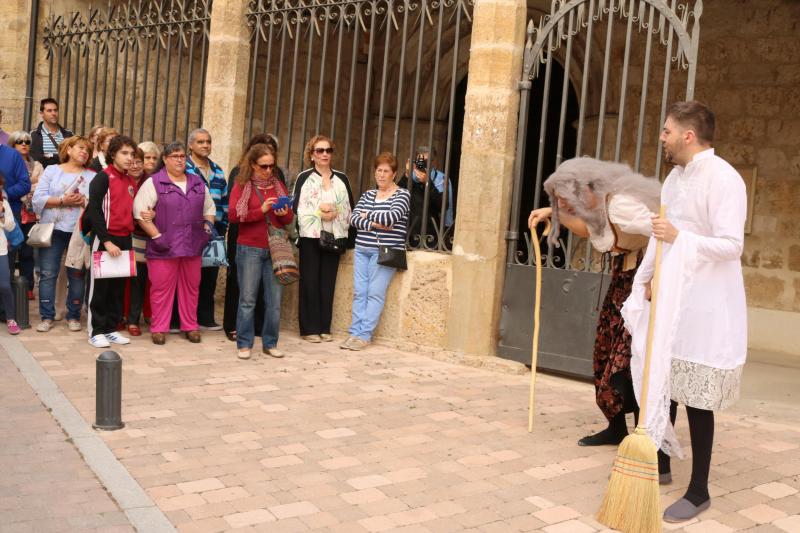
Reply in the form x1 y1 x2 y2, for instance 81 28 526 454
696 0 800 313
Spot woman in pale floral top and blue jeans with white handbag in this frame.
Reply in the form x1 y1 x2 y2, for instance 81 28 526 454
33 135 95 333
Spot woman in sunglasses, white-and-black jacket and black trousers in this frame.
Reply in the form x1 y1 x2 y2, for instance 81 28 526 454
293 135 353 342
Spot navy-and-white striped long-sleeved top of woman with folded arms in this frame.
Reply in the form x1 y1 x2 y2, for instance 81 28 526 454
350 188 411 248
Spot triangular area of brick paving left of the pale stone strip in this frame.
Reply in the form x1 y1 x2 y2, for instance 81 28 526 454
0 350 133 533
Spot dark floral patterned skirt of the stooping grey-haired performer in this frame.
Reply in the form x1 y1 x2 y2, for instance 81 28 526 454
592 256 636 420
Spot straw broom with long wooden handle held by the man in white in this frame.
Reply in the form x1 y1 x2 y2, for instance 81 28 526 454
597 205 666 533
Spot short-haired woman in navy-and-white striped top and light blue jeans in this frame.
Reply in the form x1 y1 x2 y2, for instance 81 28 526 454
341 152 411 351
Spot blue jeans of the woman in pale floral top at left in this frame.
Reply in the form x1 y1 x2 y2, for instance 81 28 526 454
39 229 86 320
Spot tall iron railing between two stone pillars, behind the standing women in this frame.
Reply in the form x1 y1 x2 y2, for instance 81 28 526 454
241 0 473 251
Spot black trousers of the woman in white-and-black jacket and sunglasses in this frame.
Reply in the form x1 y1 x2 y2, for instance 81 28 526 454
299 237 339 335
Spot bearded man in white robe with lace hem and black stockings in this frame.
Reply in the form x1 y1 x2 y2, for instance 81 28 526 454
622 102 747 522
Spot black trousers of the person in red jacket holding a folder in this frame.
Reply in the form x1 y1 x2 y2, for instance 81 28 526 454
89 235 131 337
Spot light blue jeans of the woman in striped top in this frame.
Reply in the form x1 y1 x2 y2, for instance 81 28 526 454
350 246 397 341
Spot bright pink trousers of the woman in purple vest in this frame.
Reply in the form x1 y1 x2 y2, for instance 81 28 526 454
147 257 201 333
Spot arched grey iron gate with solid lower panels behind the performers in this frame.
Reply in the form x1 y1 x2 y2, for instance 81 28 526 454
498 0 703 377
